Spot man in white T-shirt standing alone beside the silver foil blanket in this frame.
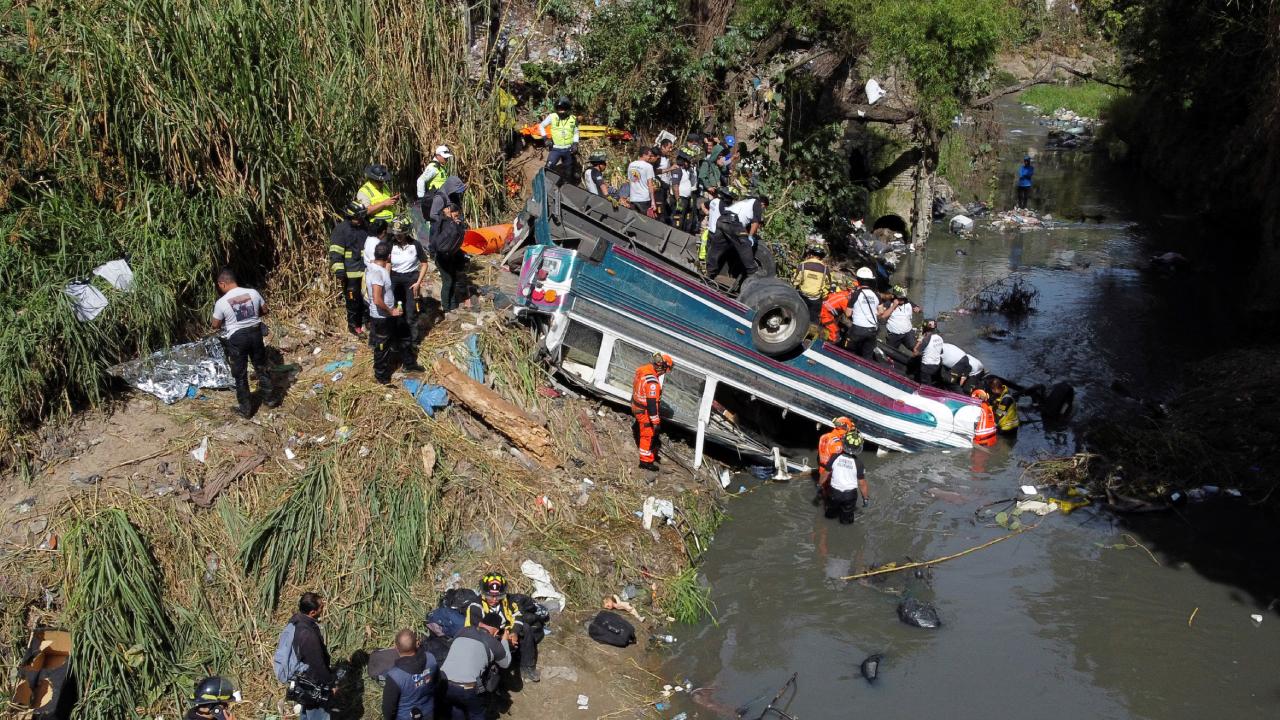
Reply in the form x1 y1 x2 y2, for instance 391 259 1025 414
212 269 280 419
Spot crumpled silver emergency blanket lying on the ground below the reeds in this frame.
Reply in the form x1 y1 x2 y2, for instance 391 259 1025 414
108 337 234 404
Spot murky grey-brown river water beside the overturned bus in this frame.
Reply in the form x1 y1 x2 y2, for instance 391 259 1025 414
664 102 1280 719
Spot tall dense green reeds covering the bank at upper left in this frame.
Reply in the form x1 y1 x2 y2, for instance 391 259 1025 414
0 0 514 433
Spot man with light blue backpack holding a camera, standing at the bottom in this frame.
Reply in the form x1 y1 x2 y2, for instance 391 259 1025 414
274 592 338 720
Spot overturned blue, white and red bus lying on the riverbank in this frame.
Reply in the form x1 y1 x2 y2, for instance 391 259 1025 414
504 173 980 464
